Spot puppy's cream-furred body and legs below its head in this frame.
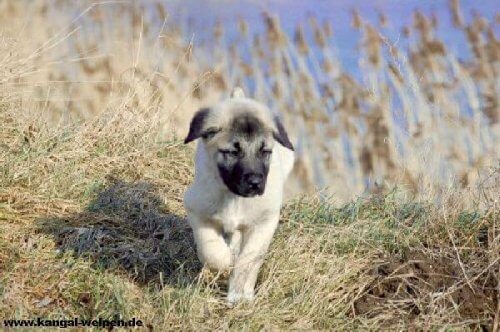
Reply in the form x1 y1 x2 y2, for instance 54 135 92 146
184 100 294 304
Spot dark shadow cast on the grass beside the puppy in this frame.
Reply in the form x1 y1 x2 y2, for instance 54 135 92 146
38 180 201 285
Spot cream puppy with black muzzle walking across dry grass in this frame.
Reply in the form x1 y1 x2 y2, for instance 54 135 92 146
184 88 294 304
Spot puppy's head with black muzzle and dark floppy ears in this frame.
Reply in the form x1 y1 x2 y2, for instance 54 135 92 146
184 90 293 197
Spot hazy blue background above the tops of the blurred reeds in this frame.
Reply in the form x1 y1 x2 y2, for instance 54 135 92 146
166 0 499 69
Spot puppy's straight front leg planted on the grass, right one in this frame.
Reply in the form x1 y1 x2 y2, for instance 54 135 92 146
227 215 279 304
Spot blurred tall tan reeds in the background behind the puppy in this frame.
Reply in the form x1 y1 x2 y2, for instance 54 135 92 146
0 0 500 202
